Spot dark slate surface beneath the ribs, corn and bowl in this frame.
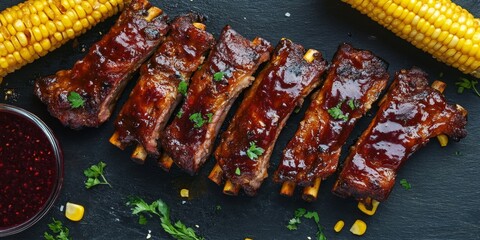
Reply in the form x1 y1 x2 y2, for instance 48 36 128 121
0 0 480 240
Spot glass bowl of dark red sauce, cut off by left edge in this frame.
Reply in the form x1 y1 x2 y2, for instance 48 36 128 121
0 103 63 237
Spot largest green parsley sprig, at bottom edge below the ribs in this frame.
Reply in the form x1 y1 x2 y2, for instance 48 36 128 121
127 197 204 240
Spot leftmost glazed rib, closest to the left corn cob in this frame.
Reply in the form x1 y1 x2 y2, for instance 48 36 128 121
35 0 168 129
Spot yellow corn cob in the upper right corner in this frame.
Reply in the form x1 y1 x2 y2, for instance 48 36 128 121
342 0 480 78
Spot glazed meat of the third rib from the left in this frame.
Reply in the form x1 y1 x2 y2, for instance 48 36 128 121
162 26 272 174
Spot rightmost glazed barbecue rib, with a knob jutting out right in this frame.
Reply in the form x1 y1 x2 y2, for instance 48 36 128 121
333 69 467 202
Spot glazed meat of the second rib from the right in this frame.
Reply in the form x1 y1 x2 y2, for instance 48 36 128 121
274 44 389 186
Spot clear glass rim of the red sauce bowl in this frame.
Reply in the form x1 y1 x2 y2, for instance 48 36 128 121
0 103 64 237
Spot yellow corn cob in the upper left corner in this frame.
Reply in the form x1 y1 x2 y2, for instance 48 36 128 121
0 0 130 83
